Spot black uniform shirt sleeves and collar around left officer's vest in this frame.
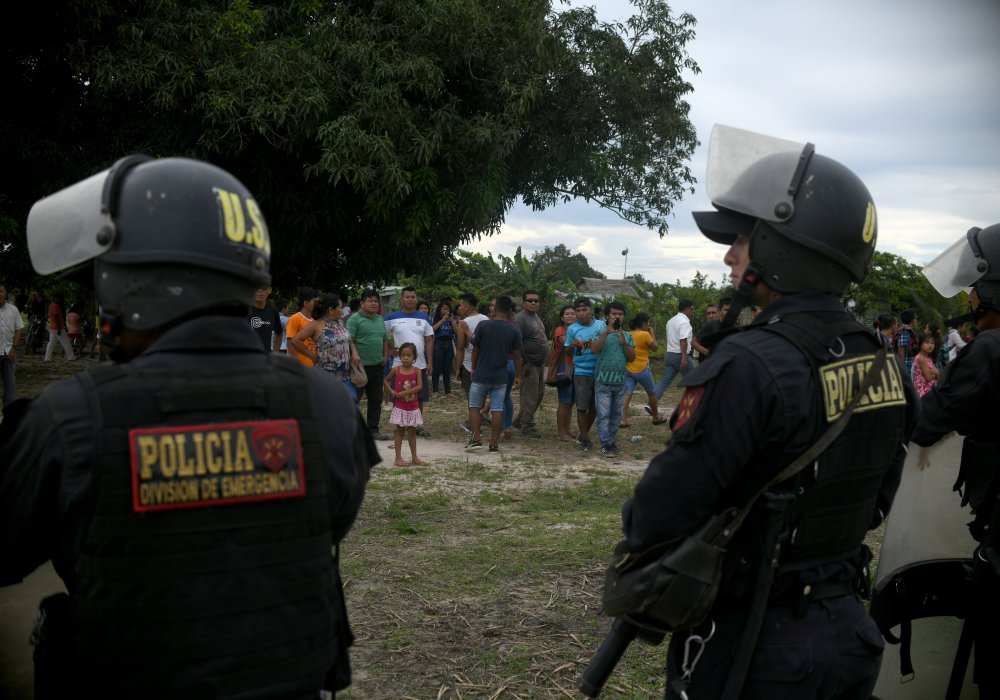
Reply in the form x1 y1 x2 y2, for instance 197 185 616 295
0 317 378 590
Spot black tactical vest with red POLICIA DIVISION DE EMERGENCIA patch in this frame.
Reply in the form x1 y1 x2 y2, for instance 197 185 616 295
71 357 341 700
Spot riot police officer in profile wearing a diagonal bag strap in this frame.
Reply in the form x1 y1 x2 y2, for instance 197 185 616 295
622 125 916 700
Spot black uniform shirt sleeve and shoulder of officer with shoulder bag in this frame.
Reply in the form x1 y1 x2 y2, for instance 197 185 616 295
622 294 917 551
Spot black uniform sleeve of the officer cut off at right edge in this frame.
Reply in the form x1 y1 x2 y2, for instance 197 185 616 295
913 329 1000 446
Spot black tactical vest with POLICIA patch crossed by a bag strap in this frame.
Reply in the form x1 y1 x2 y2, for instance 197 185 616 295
727 313 906 596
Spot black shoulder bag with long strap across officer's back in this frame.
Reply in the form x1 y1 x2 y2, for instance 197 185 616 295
602 348 886 634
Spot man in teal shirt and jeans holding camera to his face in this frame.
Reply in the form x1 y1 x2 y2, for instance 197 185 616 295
590 301 635 457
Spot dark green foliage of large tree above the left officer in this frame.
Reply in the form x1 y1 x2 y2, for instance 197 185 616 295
0 0 697 287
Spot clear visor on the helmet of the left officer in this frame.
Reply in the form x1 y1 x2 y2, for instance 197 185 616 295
26 170 114 275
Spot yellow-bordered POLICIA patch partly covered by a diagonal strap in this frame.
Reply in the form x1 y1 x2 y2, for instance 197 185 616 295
819 354 906 423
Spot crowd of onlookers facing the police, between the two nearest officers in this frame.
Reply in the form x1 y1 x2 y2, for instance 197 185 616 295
242 274 744 466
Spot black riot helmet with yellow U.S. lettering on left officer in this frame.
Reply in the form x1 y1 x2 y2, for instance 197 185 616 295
27 155 271 335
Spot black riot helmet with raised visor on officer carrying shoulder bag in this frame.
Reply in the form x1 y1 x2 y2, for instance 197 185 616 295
694 125 877 296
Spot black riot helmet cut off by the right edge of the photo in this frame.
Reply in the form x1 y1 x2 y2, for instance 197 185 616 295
924 224 1000 311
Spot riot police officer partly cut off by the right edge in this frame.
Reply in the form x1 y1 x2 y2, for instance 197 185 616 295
913 224 1000 698
